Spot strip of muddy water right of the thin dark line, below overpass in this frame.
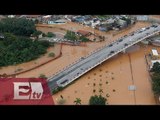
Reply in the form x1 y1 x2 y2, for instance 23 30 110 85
130 48 155 104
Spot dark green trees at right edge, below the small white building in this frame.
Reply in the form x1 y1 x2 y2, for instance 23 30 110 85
151 62 160 95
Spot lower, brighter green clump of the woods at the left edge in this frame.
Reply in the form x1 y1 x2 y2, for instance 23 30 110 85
0 33 50 66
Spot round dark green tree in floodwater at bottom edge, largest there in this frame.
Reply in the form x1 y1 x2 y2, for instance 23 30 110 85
89 95 107 105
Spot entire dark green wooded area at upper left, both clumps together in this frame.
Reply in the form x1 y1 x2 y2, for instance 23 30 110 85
0 18 50 67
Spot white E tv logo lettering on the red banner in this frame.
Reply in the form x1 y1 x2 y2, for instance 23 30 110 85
13 82 43 100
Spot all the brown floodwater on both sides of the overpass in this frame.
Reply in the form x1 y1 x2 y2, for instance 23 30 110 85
0 22 155 105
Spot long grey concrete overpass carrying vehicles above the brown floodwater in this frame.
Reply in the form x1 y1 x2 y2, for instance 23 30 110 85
48 24 160 90
